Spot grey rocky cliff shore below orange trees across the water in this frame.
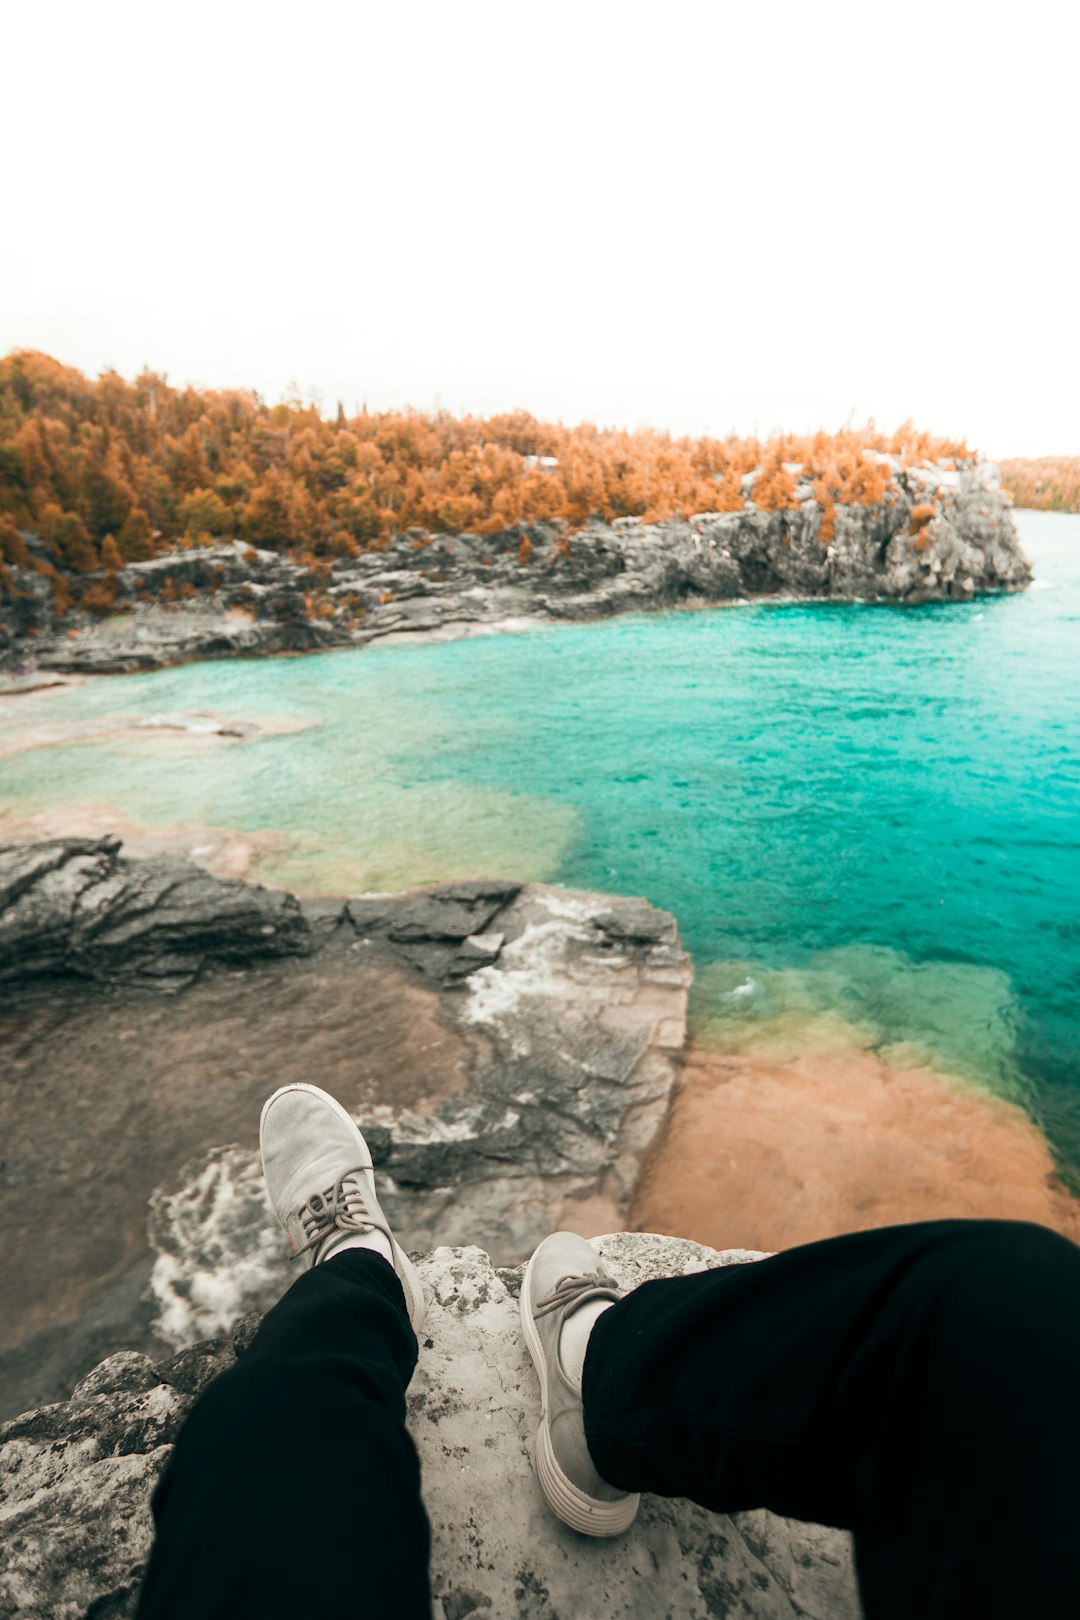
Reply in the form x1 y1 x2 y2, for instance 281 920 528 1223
0 463 1031 679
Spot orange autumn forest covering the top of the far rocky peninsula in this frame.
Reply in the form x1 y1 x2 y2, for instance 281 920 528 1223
0 350 972 595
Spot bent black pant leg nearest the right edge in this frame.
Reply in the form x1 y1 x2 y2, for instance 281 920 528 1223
583 1221 1080 1620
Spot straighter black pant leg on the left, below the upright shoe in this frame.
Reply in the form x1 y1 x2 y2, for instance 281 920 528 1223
138 1249 431 1620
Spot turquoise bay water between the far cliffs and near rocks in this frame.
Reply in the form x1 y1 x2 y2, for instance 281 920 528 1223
0 514 1080 1165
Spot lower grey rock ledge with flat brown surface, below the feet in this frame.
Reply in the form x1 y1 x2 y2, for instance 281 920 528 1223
0 839 690 1411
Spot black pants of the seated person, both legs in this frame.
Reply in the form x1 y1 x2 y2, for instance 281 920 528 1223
139 1221 1080 1620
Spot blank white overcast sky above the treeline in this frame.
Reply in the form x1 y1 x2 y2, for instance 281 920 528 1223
0 0 1080 457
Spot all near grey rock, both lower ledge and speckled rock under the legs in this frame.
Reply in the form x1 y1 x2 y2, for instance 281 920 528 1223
0 838 1075 1620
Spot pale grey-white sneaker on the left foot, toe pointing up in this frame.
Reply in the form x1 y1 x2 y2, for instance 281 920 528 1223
259 1084 426 1333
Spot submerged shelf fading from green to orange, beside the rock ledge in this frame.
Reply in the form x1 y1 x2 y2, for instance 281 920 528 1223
633 948 1080 1249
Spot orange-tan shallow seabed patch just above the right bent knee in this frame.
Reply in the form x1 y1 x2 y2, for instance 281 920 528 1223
633 1032 1080 1251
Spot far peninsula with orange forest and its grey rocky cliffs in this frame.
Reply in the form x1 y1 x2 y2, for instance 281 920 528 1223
0 352 1030 671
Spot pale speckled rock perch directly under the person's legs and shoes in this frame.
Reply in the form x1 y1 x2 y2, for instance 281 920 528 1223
0 1233 860 1620
